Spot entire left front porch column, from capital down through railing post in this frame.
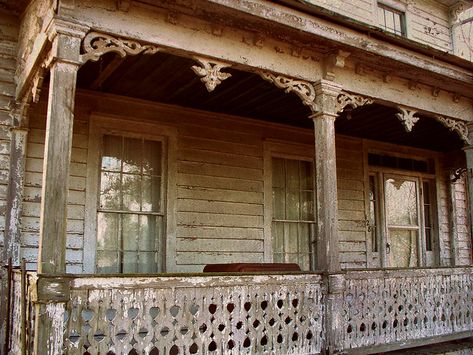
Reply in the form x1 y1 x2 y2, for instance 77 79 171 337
35 21 85 355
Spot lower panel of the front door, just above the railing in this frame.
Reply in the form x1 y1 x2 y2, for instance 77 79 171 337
388 228 419 267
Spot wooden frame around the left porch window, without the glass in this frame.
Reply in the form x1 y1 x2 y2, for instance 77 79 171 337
83 114 177 275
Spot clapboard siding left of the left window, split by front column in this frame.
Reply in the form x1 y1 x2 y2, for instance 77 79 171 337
21 100 88 273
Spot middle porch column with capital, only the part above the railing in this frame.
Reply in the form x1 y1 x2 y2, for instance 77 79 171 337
311 80 341 272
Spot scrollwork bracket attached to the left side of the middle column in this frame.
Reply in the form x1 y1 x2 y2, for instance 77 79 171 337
259 72 318 113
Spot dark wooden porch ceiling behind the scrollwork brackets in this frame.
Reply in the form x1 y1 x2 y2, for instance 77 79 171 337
78 53 463 151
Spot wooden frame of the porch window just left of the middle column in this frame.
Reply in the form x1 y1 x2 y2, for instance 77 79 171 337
263 139 317 271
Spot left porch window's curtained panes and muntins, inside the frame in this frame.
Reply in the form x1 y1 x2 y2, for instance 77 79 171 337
96 135 164 273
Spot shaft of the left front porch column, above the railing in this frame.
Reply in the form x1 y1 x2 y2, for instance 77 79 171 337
38 32 81 274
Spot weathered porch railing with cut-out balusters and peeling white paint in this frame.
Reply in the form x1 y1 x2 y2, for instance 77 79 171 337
5 267 473 355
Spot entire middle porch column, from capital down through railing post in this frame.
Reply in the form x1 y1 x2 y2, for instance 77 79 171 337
311 80 345 354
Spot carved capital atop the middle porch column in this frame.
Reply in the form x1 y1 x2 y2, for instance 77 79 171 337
310 79 342 119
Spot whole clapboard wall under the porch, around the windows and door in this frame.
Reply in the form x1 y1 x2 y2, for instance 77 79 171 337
22 91 470 273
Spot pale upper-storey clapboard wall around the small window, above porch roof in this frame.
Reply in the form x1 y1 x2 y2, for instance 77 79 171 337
300 0 453 51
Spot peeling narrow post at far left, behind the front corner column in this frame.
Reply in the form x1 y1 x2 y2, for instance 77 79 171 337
3 102 29 266
